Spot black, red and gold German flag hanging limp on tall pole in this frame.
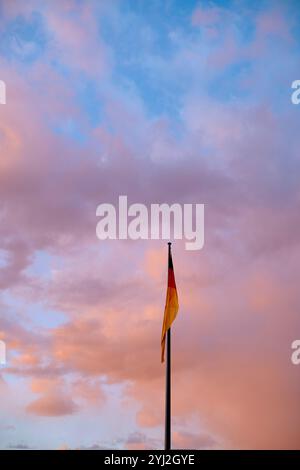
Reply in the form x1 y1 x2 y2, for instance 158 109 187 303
161 243 179 362
